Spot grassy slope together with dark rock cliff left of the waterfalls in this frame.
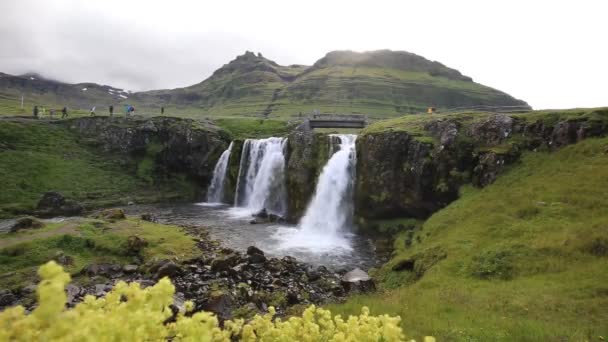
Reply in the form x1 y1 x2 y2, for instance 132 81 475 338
0 117 230 217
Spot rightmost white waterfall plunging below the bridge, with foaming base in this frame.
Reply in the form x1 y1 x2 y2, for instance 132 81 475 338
277 134 357 253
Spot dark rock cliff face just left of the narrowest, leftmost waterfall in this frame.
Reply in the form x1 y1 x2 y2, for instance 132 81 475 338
65 117 230 198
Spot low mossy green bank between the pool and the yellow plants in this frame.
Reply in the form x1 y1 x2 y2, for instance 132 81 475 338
0 219 197 288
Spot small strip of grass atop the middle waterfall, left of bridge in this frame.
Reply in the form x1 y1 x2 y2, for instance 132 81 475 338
215 118 294 139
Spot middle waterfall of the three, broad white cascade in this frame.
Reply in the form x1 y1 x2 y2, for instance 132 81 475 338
234 138 287 216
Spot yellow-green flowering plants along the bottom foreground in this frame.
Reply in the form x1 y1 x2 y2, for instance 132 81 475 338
0 262 410 342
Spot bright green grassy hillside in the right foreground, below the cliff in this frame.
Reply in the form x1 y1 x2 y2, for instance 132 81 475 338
331 138 608 341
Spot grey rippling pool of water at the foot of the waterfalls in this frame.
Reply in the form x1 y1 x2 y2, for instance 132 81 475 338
125 203 383 270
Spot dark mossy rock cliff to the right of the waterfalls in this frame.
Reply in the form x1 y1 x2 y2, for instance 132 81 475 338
355 110 608 223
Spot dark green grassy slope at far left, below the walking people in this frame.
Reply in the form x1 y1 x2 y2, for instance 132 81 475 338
0 120 192 216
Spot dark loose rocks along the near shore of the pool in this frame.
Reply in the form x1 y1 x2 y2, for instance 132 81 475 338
0 216 374 320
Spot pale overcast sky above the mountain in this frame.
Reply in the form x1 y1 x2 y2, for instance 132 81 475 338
0 0 608 109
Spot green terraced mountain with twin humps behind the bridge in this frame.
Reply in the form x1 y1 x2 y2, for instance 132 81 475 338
0 50 527 118
